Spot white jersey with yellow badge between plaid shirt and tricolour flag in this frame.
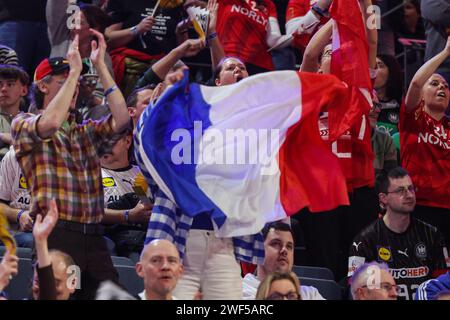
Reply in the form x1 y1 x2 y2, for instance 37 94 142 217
102 166 140 206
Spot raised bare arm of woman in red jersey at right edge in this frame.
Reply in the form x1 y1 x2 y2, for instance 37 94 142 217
405 36 450 112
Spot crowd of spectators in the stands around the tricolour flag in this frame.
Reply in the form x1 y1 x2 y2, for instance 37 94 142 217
0 0 450 300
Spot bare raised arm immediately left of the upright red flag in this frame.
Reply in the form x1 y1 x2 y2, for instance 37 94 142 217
300 20 333 72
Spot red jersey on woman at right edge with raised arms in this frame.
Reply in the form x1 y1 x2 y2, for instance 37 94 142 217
399 102 450 209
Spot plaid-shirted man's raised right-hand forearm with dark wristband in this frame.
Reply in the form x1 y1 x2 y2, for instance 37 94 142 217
90 29 130 132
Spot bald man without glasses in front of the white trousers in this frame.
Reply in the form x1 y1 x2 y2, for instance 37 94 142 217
136 239 183 300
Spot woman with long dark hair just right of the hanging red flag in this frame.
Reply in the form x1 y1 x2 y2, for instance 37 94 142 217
374 55 403 136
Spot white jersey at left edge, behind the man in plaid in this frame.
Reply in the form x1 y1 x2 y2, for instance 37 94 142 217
0 147 31 210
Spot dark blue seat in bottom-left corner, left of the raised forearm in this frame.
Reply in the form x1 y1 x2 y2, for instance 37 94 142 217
5 259 33 300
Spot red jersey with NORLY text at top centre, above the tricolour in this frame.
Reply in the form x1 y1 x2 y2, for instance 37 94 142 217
217 0 277 70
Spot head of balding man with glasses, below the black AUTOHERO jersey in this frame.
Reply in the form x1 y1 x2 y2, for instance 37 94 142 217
351 262 398 300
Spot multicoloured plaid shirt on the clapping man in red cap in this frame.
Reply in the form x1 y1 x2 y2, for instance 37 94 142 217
11 113 118 223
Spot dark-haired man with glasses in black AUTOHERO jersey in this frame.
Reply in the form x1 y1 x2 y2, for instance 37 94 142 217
348 167 450 300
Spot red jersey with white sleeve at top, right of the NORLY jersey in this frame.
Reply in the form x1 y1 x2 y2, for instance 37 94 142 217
286 0 330 51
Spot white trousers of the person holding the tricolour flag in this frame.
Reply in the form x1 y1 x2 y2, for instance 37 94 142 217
173 229 242 300
